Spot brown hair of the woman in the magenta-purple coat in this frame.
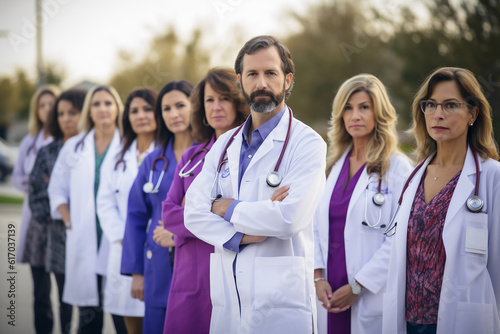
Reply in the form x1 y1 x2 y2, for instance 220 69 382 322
191 67 250 143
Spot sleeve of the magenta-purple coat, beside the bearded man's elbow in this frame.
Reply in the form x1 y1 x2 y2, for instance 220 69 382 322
161 154 196 240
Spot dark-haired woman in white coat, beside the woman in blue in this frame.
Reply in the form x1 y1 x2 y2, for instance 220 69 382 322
97 88 160 334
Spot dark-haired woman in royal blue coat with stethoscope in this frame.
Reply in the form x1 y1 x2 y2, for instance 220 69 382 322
121 80 193 334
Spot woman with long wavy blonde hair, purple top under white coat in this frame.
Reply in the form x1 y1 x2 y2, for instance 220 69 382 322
314 74 411 334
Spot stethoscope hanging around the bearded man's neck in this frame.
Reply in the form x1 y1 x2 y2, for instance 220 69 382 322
210 108 293 201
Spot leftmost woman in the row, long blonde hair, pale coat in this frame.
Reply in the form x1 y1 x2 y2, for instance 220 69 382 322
12 85 60 333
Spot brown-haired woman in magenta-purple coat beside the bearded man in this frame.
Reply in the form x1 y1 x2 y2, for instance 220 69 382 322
156 68 250 334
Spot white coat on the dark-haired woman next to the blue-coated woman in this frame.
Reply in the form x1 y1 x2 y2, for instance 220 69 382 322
97 140 154 317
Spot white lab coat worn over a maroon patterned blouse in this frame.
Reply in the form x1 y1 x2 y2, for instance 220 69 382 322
383 148 500 334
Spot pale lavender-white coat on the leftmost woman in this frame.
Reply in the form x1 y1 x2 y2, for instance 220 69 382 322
12 129 53 263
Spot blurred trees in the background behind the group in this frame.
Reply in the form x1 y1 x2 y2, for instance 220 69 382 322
0 0 500 147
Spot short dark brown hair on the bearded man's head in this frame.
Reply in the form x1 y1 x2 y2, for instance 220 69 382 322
234 35 295 101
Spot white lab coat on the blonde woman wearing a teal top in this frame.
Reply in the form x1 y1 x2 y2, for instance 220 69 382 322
48 129 120 306
